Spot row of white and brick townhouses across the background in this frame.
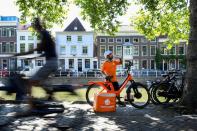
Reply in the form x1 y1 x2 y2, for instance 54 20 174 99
0 16 186 72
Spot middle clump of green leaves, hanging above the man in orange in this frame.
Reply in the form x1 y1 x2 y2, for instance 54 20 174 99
75 0 129 34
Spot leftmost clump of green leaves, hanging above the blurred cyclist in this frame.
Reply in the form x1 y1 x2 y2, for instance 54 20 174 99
16 0 69 28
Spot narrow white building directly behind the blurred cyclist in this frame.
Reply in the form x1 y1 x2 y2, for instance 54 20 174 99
17 26 45 72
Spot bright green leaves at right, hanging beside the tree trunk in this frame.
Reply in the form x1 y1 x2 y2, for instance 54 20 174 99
134 0 190 46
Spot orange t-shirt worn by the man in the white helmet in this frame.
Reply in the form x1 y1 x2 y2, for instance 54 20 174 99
101 60 121 82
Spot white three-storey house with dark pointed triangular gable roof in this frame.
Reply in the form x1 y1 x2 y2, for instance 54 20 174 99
56 18 98 72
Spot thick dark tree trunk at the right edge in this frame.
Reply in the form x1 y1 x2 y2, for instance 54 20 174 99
182 0 197 110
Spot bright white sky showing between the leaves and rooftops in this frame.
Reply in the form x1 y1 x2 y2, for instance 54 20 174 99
0 0 138 31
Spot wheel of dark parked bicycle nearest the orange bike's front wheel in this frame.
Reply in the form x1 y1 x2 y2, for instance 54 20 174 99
153 83 170 104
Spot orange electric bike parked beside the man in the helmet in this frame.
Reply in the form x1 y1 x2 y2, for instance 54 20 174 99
86 62 150 109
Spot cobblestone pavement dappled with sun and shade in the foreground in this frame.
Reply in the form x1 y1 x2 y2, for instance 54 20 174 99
0 103 197 131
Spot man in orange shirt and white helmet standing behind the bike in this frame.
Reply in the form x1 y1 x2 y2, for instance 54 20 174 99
101 50 125 106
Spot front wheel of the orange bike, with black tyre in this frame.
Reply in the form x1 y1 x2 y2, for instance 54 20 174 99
127 83 150 109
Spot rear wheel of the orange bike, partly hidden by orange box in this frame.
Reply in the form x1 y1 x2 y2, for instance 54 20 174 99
86 84 103 106
